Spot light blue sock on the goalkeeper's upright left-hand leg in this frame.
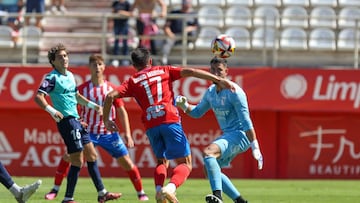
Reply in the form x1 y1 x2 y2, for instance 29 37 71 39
204 157 222 191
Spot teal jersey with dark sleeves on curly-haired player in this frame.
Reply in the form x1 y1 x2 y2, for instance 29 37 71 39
38 69 79 118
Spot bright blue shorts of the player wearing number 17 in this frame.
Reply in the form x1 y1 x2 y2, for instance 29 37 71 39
146 123 191 160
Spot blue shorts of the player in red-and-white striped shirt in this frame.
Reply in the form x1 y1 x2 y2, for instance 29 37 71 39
90 132 129 159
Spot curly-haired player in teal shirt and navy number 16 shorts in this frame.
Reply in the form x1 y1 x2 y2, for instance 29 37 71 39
35 44 121 203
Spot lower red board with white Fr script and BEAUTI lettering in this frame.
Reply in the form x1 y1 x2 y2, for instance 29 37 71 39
281 113 360 179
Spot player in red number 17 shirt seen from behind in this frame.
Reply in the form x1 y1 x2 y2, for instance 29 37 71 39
103 48 231 203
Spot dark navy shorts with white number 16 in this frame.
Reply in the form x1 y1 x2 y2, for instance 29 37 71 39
57 117 91 154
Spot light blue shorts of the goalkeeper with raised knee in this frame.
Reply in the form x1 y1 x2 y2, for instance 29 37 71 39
212 131 250 167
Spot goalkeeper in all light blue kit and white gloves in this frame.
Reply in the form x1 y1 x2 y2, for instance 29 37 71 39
176 57 263 203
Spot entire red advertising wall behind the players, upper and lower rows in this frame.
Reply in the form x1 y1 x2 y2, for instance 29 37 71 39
0 67 360 179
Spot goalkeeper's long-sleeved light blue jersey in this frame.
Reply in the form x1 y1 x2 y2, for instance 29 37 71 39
189 82 253 133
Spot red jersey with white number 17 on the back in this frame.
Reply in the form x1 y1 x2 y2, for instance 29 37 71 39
116 66 181 129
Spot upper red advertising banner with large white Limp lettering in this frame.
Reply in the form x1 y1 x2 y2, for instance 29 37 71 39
0 67 360 112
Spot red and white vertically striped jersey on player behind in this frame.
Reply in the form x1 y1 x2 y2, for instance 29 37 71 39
78 80 124 134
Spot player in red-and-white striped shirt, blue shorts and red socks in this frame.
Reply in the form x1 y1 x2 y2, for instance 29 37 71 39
45 54 149 201
